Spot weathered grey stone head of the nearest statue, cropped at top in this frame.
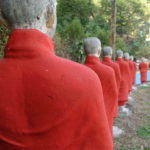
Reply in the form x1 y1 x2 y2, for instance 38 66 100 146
0 0 57 37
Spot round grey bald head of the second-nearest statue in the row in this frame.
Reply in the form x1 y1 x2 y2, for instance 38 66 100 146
84 37 101 57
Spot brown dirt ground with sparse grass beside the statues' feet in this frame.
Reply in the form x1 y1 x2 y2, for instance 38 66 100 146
115 83 150 150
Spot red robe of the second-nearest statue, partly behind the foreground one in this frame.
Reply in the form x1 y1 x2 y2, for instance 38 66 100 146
85 56 118 129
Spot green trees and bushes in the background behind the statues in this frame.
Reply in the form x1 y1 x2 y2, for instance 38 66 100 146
0 0 150 62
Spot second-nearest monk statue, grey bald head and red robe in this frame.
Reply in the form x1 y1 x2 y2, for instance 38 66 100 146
84 37 118 133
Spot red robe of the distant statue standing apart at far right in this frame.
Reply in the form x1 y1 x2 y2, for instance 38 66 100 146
139 62 148 83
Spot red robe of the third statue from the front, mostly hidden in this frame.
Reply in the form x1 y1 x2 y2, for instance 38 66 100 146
102 57 121 117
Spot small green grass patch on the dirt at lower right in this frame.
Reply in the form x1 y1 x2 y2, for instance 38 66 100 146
137 125 150 138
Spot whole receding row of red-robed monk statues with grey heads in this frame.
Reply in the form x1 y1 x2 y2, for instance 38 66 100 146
0 0 148 150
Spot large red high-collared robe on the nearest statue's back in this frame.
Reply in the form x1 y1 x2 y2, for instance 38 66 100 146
0 29 113 150
